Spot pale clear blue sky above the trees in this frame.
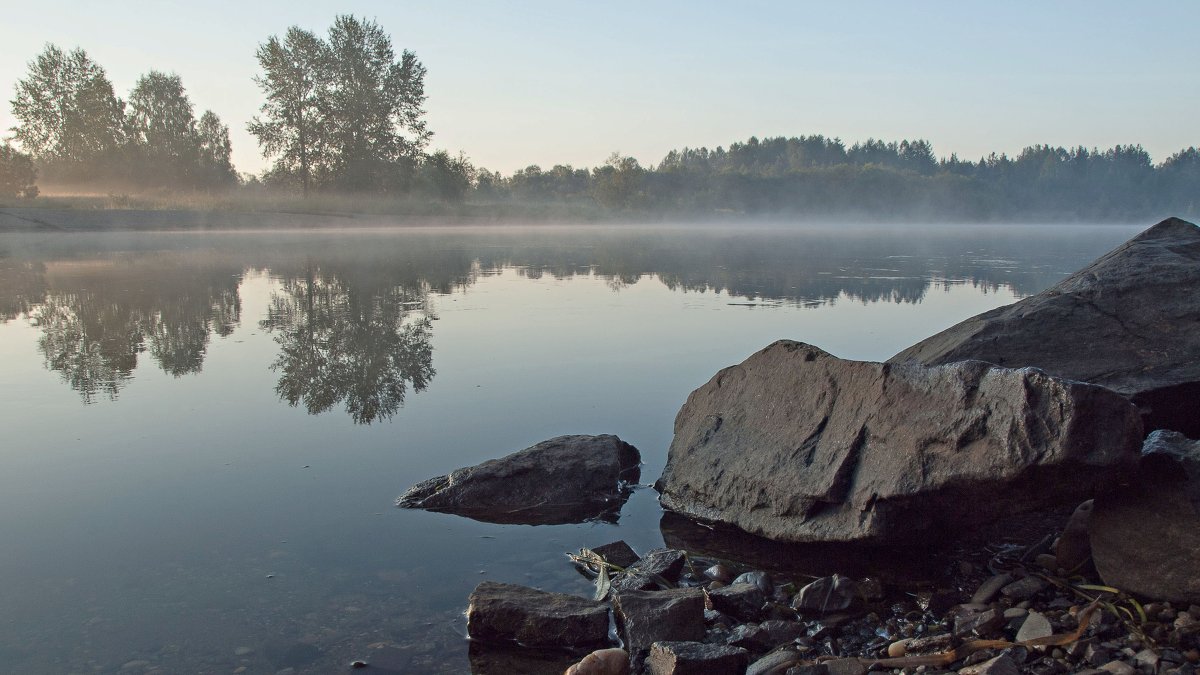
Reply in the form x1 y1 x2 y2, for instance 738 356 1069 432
0 0 1200 173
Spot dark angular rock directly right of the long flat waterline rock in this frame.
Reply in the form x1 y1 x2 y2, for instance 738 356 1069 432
613 589 704 663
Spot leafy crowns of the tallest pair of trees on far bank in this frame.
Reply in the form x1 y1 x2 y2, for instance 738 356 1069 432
247 16 432 193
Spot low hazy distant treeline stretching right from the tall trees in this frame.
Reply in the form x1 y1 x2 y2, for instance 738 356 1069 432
474 135 1200 221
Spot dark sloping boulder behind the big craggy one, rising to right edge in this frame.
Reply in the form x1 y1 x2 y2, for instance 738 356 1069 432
890 217 1200 436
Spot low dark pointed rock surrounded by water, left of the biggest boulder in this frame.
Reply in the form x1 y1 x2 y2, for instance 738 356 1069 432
396 435 641 525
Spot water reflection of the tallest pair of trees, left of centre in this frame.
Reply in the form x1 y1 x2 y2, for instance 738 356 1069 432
259 265 434 424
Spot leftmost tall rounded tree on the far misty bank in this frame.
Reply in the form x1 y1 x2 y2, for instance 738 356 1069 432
12 44 124 178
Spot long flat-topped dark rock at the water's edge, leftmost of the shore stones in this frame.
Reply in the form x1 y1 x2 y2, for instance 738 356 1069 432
467 581 608 647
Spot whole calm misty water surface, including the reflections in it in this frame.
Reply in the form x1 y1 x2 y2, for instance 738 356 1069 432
0 220 1136 674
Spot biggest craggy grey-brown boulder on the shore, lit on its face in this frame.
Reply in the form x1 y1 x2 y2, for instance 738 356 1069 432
656 340 1141 544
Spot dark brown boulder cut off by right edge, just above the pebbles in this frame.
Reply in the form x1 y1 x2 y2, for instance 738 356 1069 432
1087 431 1200 604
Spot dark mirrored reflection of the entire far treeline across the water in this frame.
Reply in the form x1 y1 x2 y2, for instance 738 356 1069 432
0 227 1128 413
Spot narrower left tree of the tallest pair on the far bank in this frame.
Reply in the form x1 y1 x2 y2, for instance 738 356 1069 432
248 26 329 195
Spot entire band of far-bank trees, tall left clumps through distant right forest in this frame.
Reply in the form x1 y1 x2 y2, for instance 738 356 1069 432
0 16 1200 221
